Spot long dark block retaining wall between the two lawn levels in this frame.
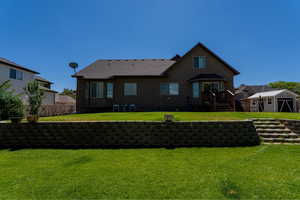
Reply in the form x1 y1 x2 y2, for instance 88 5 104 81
0 121 260 149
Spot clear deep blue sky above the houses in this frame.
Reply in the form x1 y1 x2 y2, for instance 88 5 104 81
0 0 300 91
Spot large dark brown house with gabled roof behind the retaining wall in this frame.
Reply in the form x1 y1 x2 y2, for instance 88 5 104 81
73 43 239 113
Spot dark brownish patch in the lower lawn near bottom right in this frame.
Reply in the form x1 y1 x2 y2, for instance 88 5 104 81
219 180 241 199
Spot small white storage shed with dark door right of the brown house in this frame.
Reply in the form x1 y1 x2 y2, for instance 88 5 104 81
248 89 298 112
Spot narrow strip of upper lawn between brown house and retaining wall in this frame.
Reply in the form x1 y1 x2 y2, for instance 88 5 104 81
41 112 300 121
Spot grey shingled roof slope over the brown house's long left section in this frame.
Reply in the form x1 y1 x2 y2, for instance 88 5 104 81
73 59 176 79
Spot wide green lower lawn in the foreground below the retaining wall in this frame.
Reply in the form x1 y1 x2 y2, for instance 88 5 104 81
0 145 300 199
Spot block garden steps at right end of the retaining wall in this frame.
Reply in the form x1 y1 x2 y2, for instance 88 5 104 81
253 119 300 145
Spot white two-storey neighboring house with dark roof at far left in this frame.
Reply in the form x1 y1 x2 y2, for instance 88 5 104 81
0 58 55 105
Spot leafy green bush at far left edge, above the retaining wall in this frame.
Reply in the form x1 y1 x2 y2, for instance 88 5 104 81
0 81 24 120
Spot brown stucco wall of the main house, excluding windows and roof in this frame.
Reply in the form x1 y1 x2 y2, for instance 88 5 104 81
77 47 238 113
